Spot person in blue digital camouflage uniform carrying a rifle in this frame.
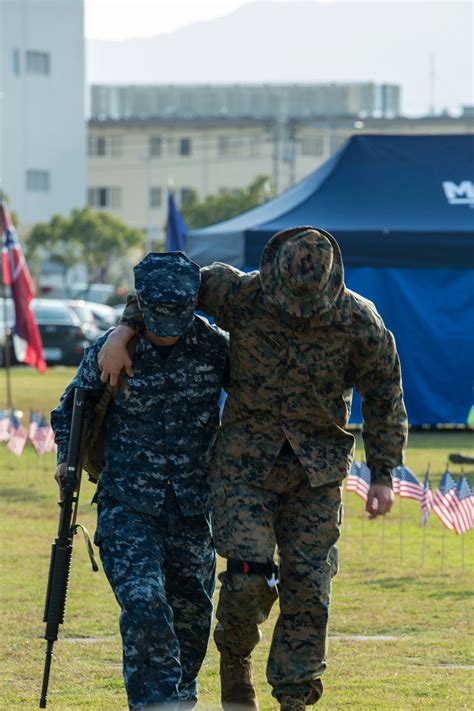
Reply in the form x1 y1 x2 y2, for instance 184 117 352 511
52 252 228 710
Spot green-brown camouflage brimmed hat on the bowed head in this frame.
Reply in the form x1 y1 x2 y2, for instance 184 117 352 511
260 227 344 320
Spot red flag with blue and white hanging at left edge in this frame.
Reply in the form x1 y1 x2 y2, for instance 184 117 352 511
0 203 46 373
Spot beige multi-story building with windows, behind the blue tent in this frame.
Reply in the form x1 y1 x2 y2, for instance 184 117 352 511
88 113 472 240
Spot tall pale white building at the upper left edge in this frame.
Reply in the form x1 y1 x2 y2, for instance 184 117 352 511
0 0 86 229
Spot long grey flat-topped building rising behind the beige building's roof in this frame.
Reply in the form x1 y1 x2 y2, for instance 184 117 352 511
91 82 401 119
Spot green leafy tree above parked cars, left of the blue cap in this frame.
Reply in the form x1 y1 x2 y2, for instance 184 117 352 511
27 207 145 292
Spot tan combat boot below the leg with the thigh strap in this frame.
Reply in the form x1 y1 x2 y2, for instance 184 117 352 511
220 654 258 711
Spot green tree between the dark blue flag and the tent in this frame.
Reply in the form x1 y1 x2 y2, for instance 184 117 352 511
181 175 271 229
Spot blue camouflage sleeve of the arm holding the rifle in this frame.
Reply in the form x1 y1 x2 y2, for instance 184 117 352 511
51 332 109 464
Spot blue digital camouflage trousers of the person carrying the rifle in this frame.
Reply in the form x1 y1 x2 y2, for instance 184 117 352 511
95 488 215 709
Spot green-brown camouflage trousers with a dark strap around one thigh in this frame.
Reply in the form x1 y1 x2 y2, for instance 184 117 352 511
213 448 341 704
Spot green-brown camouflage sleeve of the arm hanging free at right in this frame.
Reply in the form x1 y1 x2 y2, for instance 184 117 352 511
355 323 408 486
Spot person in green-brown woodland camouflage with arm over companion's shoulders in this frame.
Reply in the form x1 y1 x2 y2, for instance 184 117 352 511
111 227 407 709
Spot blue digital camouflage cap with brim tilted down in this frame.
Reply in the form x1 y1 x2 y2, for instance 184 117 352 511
133 252 201 336
